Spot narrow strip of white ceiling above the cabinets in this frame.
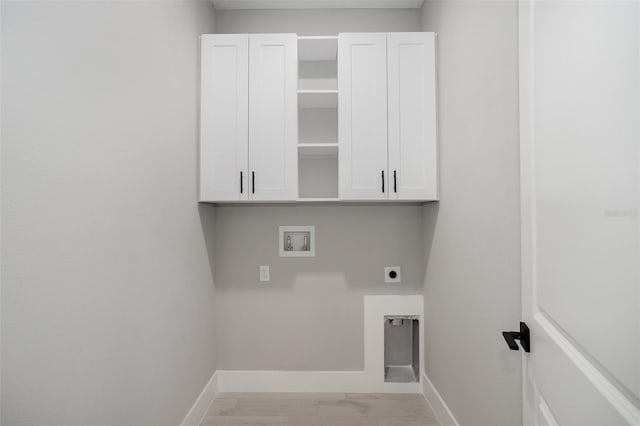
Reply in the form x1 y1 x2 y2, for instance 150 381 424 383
211 0 423 9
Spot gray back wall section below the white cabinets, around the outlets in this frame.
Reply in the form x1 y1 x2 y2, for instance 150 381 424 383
215 205 423 371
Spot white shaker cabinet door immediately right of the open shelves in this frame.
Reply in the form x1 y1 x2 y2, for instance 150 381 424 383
338 33 389 200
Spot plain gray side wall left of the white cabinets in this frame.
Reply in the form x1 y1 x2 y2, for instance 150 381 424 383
1 2 215 426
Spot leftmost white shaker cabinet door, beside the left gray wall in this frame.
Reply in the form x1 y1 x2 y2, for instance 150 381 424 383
200 35 249 201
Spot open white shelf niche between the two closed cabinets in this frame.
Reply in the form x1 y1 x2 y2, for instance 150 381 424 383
298 36 338 202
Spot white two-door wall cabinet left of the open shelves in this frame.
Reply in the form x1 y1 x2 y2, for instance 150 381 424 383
200 34 298 202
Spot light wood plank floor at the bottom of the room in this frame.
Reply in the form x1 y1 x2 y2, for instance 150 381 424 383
201 393 439 426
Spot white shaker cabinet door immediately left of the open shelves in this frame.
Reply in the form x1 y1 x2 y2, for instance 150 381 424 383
249 34 298 201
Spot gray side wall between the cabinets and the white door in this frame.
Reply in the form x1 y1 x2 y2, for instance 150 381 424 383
423 1 521 426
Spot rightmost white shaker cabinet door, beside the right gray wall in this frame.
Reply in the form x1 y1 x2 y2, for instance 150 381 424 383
387 33 438 200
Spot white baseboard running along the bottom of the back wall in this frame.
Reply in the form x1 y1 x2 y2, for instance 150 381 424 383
217 370 422 393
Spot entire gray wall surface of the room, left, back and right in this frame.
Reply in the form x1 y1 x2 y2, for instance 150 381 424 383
1 2 520 425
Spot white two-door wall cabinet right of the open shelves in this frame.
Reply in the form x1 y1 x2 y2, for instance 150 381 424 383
338 33 438 201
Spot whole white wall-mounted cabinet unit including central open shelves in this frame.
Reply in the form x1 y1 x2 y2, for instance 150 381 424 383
200 33 438 202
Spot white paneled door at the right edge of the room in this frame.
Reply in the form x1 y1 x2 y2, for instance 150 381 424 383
520 1 640 426
